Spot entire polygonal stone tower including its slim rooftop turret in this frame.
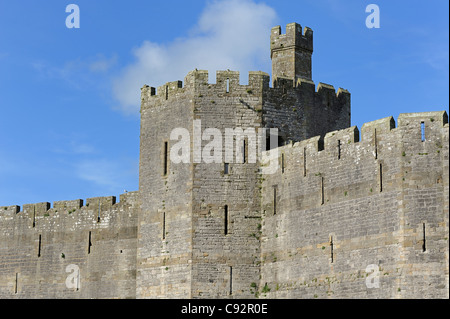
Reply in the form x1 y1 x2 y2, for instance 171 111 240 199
136 23 350 298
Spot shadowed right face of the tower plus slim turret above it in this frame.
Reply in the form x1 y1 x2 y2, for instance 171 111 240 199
263 23 351 144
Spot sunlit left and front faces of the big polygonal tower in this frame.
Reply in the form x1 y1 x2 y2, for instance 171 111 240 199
136 70 269 298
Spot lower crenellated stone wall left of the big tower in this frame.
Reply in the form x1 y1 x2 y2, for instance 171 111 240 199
0 192 139 299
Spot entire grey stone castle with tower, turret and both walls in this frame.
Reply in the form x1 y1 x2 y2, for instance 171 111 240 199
0 23 449 298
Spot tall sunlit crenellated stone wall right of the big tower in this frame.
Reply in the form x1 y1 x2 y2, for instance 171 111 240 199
261 112 449 298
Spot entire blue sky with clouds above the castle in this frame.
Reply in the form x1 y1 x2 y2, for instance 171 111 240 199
0 0 449 206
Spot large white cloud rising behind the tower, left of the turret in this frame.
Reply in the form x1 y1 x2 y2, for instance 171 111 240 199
113 0 276 113
